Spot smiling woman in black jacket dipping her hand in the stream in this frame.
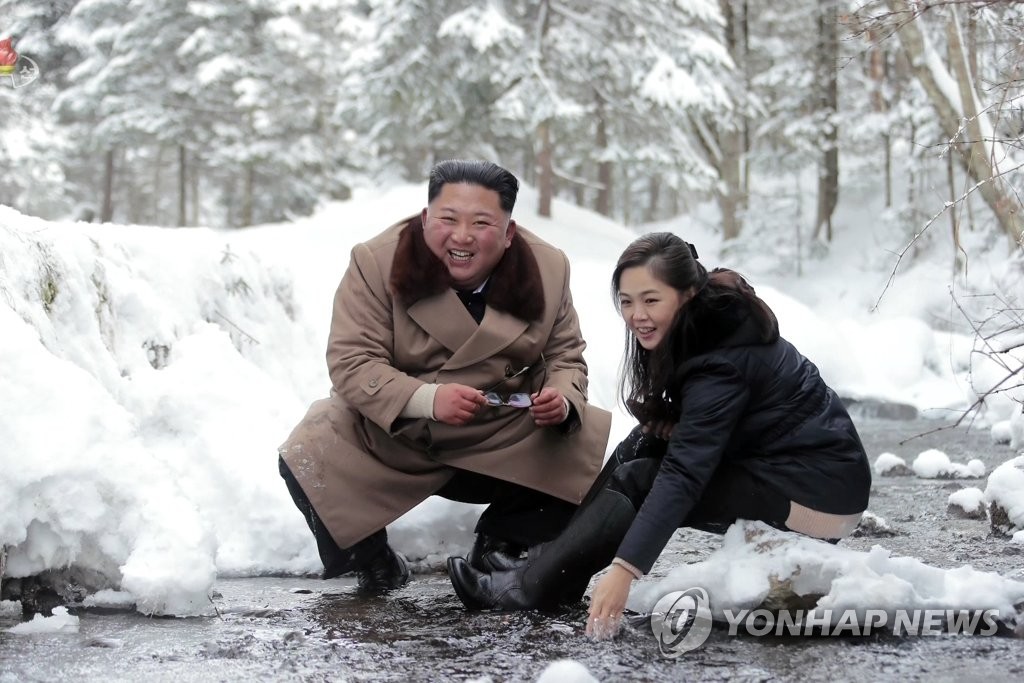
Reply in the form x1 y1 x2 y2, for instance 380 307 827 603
449 232 870 636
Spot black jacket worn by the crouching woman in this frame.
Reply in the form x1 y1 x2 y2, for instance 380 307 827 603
616 301 871 572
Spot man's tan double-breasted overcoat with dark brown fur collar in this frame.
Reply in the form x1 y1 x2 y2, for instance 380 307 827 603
280 216 611 548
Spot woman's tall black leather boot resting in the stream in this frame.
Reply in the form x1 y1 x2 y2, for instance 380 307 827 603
447 488 636 610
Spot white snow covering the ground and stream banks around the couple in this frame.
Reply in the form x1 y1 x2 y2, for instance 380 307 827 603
0 184 1024 624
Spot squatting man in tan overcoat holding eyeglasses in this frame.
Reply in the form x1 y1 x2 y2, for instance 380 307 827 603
280 161 611 592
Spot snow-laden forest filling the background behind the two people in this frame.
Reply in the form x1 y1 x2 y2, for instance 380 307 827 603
0 0 1024 267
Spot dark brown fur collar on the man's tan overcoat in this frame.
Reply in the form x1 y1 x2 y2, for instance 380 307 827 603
388 216 545 323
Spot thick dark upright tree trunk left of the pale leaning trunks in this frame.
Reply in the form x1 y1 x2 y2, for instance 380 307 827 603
814 0 839 242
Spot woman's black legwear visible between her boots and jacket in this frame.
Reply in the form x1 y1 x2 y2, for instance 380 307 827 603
581 427 790 533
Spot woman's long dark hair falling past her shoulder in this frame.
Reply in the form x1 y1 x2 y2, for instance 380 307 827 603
611 232 778 424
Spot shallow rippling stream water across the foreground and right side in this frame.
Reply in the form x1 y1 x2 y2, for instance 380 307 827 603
0 418 1024 683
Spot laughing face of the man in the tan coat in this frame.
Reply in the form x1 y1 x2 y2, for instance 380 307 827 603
423 182 515 290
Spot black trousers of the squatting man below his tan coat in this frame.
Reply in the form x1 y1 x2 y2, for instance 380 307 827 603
278 457 577 579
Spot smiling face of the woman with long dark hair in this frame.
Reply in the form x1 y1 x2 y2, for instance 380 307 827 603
618 265 692 351
